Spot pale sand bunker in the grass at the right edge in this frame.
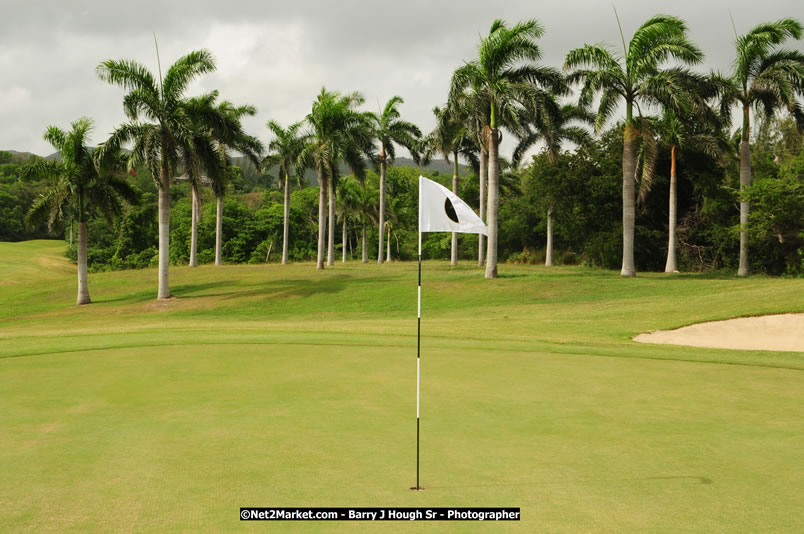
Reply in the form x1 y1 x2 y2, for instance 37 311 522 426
634 313 804 352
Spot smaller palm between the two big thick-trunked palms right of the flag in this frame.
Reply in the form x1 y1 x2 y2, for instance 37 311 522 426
512 101 594 267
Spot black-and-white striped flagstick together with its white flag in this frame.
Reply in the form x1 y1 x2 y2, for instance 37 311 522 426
410 176 488 491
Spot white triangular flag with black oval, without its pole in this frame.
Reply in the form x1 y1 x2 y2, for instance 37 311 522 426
419 176 488 235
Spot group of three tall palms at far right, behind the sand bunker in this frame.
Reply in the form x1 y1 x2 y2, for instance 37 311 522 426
565 15 804 276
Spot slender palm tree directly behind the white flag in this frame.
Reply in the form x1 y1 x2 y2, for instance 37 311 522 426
428 99 478 266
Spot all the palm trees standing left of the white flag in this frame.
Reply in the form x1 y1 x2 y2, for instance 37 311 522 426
26 50 428 304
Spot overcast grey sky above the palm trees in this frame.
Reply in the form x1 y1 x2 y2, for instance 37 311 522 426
0 0 804 159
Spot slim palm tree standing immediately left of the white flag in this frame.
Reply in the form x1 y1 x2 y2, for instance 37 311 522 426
370 96 422 263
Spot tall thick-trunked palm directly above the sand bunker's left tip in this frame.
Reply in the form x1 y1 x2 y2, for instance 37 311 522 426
564 12 703 276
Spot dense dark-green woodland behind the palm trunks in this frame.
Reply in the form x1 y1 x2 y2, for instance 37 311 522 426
7 113 804 275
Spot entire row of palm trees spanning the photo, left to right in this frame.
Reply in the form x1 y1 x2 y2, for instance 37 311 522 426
22 15 804 303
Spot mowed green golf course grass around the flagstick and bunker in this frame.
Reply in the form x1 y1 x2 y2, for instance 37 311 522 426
0 241 804 532
